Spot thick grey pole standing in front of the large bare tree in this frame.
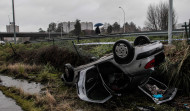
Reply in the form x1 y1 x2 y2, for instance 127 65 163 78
168 0 173 44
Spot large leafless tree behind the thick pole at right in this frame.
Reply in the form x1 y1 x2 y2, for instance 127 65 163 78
145 2 177 30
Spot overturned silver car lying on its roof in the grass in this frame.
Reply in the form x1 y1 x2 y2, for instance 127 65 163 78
61 36 177 104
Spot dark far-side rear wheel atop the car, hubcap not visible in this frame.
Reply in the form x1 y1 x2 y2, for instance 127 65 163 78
134 36 150 46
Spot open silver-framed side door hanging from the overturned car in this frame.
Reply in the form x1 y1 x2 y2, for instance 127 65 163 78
76 66 112 103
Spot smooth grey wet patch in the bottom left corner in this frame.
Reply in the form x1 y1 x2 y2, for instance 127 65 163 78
0 91 23 111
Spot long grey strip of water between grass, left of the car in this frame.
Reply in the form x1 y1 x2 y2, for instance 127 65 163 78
0 75 43 94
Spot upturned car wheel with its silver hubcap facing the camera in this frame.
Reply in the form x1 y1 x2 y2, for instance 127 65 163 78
113 39 134 64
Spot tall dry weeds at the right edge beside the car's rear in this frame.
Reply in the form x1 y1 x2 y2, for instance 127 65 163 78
158 41 190 96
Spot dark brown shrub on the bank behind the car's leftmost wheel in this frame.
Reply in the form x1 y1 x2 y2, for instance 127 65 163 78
14 46 90 70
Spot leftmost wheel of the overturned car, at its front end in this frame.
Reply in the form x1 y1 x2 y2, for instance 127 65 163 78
62 63 75 85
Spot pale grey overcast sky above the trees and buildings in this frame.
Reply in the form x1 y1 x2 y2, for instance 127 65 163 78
0 0 190 32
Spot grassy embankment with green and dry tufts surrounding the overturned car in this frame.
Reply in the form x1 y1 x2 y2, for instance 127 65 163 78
0 38 190 111
